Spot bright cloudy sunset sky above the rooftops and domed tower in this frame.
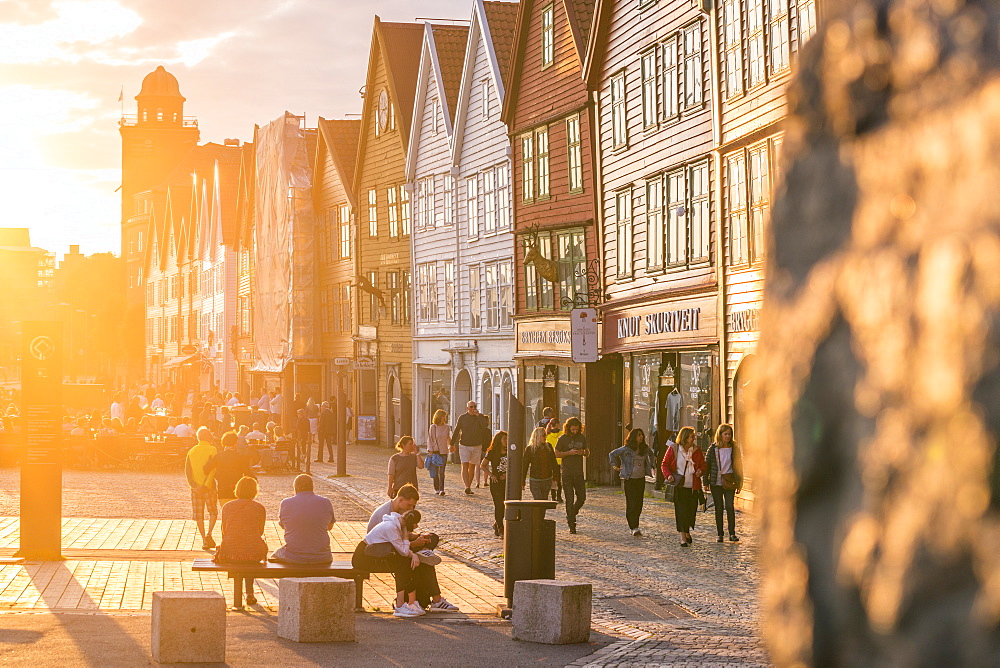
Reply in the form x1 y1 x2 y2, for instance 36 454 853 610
0 0 472 255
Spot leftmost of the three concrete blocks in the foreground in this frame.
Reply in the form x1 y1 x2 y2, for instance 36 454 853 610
150 591 226 663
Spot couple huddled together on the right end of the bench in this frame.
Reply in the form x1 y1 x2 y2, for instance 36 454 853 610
351 484 458 617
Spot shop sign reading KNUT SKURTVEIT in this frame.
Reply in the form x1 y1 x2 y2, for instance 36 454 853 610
604 297 716 351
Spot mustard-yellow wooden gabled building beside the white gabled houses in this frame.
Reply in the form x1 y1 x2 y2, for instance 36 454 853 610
352 16 424 445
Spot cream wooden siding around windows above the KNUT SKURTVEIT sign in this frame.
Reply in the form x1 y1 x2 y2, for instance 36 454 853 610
598 0 719 306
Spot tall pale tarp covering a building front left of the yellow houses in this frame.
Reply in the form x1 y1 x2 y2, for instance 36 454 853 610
253 112 316 372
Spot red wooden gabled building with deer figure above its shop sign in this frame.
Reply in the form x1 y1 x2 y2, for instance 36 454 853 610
502 0 616 480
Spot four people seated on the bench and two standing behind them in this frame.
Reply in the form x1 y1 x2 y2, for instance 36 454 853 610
184 426 458 617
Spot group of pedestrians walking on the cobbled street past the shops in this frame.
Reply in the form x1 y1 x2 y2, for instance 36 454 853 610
387 401 743 547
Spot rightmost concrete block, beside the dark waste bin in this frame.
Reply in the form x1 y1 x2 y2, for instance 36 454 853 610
512 580 594 645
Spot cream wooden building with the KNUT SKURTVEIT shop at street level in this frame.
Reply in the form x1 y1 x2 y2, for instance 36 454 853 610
586 0 720 460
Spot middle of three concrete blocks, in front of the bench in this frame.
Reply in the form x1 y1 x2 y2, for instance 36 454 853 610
278 578 355 642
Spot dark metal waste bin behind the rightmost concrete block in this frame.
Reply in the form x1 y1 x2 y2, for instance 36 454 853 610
503 499 557 606
